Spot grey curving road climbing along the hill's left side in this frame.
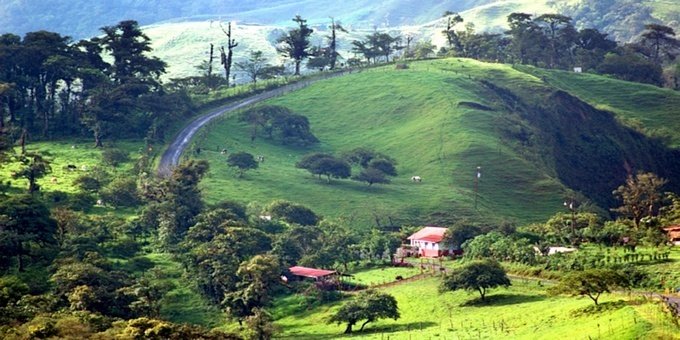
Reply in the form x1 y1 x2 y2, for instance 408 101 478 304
157 71 351 177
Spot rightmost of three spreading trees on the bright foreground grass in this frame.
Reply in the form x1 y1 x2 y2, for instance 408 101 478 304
550 269 628 305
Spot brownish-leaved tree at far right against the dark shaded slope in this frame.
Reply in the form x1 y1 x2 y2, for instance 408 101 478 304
613 172 668 228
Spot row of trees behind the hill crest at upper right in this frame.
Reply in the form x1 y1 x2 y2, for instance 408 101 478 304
349 12 680 89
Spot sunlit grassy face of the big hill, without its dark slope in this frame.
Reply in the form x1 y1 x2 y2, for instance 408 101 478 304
191 59 563 225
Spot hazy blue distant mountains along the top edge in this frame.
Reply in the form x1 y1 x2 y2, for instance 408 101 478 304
0 0 680 40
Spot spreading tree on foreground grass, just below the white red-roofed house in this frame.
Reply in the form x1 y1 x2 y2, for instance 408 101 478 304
440 260 511 300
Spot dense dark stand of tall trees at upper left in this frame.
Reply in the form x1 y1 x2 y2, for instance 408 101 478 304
0 21 191 147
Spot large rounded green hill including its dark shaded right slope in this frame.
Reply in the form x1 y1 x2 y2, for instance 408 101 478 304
190 59 677 225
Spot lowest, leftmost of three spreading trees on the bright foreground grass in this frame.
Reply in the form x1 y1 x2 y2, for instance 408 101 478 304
329 290 400 334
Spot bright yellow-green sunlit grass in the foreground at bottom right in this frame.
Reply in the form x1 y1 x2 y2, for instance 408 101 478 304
273 277 678 339
